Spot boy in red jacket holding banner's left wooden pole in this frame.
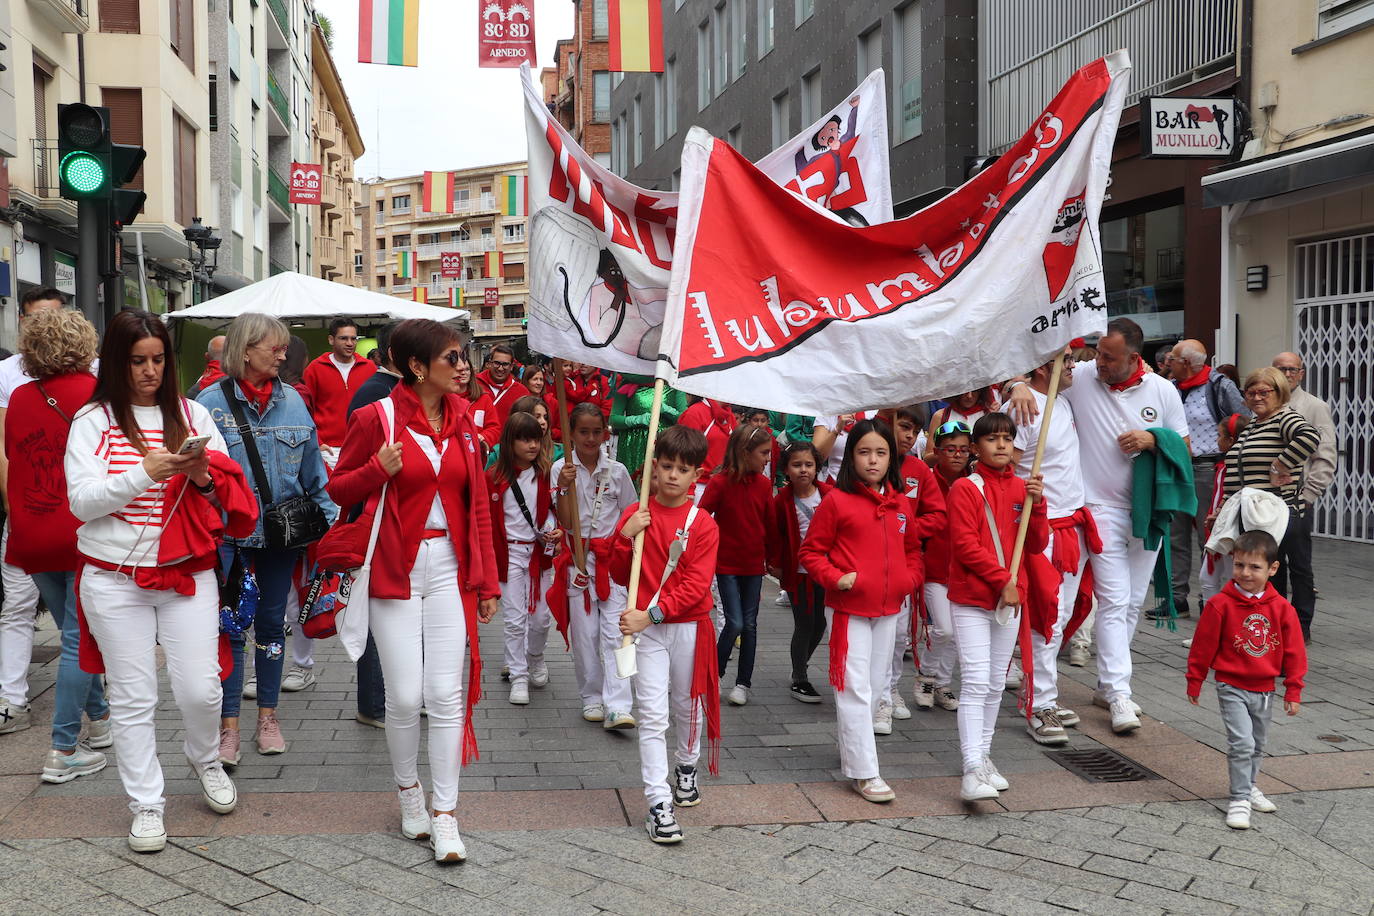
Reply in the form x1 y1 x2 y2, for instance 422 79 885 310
610 426 720 843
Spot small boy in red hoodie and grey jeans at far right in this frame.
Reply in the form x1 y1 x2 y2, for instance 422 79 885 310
1187 521 1307 829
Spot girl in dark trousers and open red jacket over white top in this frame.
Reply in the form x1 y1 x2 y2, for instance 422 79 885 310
768 442 831 703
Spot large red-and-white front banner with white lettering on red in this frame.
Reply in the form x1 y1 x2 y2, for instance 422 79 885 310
660 51 1131 416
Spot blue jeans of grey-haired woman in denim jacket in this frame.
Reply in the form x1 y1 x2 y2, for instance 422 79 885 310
220 545 301 718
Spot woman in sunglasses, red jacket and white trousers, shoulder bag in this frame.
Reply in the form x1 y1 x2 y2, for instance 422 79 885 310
328 319 500 861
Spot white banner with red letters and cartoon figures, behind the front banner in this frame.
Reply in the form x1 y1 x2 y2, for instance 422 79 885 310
521 69 892 375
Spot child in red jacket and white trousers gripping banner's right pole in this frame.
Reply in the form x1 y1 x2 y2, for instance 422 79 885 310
948 413 1050 802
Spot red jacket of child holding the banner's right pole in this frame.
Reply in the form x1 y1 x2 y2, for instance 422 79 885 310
948 461 1050 611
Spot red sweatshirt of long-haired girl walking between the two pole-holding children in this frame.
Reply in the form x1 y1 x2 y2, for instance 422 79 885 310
798 486 925 617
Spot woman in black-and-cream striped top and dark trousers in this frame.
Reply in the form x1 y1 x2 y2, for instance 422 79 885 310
1225 365 1322 640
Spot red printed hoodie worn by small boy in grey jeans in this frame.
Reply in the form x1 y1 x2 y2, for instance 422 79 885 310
1187 582 1307 703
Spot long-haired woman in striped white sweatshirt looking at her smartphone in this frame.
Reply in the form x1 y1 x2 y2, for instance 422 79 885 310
66 310 257 853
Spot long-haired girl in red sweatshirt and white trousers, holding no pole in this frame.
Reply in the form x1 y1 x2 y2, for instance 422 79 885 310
798 420 922 802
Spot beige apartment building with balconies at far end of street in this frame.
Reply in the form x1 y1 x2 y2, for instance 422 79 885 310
357 162 529 342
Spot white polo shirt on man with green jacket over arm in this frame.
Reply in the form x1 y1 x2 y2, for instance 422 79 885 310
1063 363 1189 509
